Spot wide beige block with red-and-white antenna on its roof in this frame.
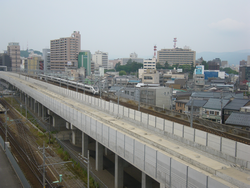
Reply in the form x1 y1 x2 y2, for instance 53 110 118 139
157 48 196 66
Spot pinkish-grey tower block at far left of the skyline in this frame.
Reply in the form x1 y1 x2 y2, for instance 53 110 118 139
7 42 21 72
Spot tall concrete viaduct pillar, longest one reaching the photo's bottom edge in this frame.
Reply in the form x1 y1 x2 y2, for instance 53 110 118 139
115 154 123 188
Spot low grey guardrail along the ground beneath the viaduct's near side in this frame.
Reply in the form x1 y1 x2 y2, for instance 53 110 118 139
56 138 108 188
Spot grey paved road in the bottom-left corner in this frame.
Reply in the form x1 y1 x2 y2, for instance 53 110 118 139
0 146 22 188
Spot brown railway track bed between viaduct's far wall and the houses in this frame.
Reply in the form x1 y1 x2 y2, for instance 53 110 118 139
20 77 250 145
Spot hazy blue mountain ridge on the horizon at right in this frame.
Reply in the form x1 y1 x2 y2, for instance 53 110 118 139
196 49 250 65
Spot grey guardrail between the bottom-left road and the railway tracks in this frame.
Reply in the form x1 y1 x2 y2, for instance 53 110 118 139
0 136 31 188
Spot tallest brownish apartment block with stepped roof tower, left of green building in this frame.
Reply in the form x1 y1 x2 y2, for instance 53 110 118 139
50 31 81 71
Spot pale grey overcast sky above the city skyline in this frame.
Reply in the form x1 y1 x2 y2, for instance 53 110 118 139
0 0 250 59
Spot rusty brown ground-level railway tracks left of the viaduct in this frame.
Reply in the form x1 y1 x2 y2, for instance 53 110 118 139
0 99 53 187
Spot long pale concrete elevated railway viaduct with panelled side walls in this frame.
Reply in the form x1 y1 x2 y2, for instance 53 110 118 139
0 72 250 188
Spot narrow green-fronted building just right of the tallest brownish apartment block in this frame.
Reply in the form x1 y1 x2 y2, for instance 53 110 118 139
78 50 91 76
